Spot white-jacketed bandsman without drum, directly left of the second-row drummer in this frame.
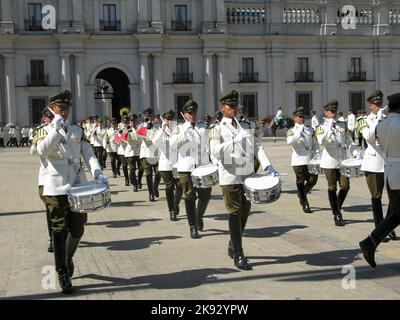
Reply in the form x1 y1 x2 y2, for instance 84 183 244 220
152 110 183 221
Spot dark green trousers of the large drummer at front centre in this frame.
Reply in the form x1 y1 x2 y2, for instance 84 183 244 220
221 184 251 256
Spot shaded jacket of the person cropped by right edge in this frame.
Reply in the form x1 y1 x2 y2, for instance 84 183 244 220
376 113 400 190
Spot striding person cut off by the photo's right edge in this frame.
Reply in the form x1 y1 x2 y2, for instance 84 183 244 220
360 93 400 268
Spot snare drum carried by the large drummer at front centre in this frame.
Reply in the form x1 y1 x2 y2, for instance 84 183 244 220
244 174 281 203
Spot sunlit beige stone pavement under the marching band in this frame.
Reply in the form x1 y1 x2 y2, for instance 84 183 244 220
0 140 400 300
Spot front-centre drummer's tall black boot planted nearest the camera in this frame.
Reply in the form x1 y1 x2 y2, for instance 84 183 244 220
229 214 252 270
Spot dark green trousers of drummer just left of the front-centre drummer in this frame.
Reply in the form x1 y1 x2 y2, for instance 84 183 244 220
178 172 212 227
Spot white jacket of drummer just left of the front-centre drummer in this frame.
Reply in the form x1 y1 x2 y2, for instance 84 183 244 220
170 122 210 172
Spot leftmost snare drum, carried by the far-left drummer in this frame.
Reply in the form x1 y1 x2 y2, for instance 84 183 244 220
68 180 111 213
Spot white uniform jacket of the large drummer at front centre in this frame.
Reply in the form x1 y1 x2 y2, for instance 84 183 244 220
210 117 271 186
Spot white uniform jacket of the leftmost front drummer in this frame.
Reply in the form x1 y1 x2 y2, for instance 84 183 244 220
36 122 102 196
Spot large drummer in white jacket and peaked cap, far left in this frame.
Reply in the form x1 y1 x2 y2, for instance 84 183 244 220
35 90 108 293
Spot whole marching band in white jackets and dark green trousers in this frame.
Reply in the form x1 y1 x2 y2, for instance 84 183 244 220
31 90 400 293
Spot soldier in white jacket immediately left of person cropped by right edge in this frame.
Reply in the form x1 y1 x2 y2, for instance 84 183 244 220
357 90 396 241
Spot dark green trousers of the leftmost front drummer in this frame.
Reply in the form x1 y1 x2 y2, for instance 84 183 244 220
43 195 87 272
